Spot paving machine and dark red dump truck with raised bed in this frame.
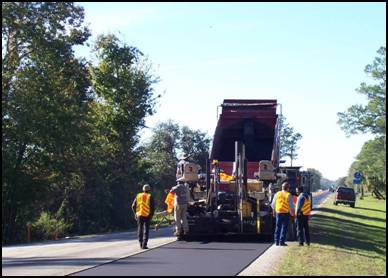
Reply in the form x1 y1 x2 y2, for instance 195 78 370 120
182 99 285 238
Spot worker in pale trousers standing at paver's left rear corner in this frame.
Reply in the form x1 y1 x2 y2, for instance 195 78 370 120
170 177 190 239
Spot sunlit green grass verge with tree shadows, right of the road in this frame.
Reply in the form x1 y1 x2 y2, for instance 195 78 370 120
273 193 386 276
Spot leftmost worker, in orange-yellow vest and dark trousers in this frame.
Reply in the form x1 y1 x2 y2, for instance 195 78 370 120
132 184 155 249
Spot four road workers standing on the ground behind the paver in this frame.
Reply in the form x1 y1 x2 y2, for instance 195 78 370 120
132 178 312 249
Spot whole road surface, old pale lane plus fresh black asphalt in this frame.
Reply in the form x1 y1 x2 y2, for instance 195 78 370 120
2 192 330 276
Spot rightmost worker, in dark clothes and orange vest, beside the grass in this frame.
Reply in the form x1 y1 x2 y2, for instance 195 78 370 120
295 187 311 246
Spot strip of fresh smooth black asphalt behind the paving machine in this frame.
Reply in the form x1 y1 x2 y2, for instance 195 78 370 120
73 241 272 276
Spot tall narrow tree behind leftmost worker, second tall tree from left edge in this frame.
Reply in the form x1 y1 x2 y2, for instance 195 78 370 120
90 34 159 230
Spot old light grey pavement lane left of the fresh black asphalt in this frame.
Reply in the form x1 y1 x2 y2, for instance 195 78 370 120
2 227 176 276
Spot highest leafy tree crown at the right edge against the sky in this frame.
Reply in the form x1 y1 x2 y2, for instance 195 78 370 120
338 47 386 137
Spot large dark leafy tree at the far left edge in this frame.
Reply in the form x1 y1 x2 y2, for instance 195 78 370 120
2 2 90 242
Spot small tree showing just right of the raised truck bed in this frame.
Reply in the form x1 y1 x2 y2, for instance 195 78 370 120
280 116 302 166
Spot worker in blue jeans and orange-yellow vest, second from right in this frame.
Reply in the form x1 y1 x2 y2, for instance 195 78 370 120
271 182 295 246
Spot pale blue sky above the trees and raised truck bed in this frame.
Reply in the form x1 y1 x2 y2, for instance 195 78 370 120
77 2 386 180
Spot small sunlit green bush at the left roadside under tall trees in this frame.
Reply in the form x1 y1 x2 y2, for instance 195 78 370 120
32 212 71 239
